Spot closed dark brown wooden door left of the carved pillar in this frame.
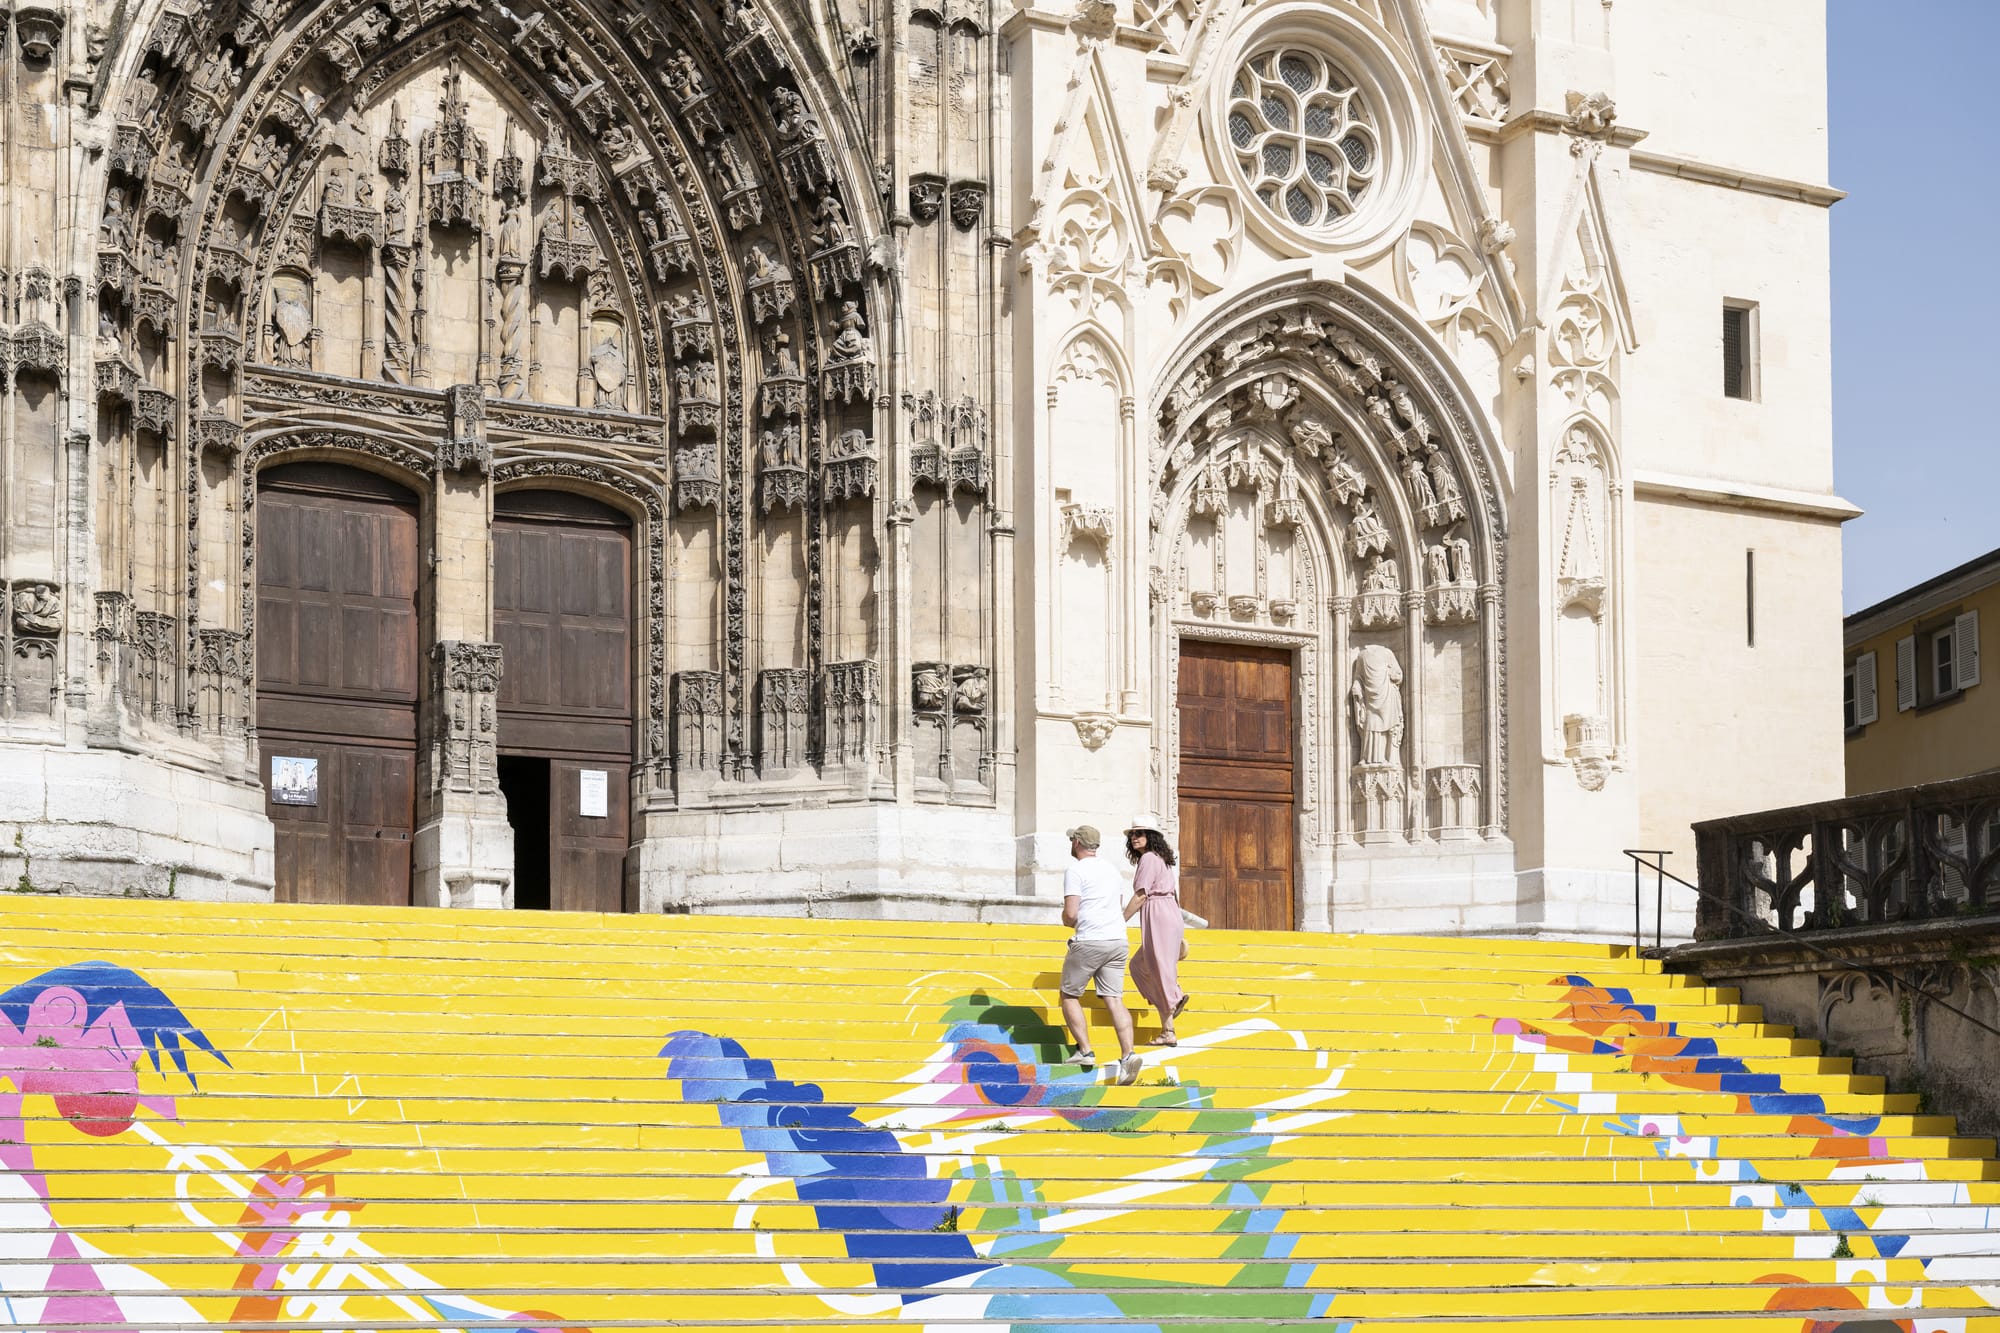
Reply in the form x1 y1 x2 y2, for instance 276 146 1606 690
256 462 418 905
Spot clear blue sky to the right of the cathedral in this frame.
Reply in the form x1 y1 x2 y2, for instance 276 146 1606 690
1832 0 2000 610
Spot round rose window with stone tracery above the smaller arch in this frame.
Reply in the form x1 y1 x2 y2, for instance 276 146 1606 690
1228 46 1382 230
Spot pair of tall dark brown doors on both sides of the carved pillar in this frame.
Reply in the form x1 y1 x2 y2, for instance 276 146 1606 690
256 462 634 911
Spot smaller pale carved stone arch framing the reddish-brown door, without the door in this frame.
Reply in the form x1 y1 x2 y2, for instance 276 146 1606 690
1150 276 1506 872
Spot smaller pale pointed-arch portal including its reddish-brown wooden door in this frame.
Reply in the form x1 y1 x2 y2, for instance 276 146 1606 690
1150 278 1506 927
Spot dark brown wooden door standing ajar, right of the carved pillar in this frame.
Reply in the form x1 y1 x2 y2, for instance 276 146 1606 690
494 490 634 911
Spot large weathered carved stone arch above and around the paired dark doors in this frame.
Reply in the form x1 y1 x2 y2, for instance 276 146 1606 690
68 0 900 789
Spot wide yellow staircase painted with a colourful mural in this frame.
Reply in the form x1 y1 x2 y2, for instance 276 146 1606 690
0 897 2000 1333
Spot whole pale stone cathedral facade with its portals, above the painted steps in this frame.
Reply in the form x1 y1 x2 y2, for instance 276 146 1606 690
0 0 1854 933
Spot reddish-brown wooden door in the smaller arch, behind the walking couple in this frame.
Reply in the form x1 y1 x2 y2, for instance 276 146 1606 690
1178 640 1298 931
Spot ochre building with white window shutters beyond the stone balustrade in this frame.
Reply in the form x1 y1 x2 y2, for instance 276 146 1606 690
1842 550 2000 795
